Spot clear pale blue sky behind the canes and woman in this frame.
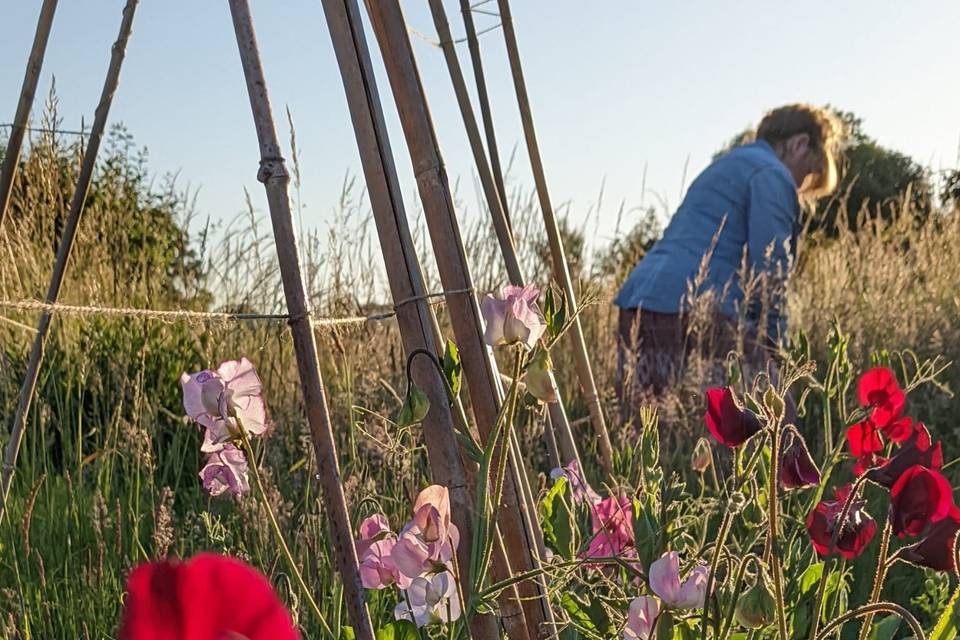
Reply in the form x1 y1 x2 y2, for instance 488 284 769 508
0 0 960 248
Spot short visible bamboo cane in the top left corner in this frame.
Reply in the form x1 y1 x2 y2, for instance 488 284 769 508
0 0 57 229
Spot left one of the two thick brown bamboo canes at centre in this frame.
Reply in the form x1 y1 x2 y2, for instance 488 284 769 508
323 0 506 640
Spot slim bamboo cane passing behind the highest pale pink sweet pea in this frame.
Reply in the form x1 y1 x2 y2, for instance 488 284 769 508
429 0 580 467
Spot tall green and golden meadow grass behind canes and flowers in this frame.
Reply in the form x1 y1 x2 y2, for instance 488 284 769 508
0 104 960 638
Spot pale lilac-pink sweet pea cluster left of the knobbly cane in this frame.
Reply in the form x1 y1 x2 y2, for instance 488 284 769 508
180 358 269 498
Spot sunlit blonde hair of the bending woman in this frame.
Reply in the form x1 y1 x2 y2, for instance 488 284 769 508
757 104 843 197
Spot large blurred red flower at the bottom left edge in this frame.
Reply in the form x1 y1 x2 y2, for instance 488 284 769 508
119 553 300 640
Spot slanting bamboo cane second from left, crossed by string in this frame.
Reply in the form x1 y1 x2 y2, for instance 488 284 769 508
0 0 139 523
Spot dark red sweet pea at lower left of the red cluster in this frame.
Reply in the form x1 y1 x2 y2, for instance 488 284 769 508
807 484 877 560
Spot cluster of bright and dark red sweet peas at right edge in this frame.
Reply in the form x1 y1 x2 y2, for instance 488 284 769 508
807 367 960 571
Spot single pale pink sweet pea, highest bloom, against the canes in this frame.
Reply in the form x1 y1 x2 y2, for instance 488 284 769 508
480 284 547 349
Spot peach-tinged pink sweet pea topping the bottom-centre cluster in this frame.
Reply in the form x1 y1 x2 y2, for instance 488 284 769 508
390 485 460 588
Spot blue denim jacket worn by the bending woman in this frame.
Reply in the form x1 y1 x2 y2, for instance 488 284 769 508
614 141 800 341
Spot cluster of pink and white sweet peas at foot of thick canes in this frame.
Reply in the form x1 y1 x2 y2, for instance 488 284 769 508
356 485 461 627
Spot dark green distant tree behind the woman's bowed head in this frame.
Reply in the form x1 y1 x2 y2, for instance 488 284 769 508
713 109 928 235
